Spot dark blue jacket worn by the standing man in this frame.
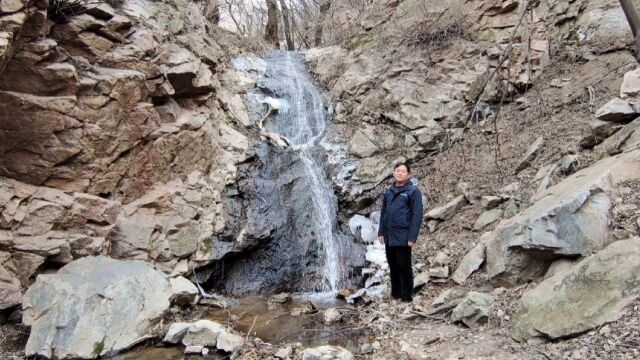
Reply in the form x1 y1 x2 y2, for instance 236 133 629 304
378 181 423 246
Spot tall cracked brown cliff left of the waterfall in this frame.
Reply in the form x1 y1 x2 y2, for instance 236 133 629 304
0 0 260 298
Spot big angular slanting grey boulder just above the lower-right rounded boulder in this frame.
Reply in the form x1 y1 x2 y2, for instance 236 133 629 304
454 150 640 285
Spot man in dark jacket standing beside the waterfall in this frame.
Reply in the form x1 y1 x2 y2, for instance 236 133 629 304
378 163 423 302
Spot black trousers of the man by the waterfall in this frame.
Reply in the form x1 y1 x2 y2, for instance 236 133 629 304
385 245 413 301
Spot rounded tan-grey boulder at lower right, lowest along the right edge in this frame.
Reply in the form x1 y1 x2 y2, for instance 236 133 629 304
511 238 640 341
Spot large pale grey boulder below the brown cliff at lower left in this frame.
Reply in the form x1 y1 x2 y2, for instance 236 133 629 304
22 256 181 359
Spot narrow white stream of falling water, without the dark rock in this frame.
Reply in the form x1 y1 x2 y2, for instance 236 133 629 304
264 52 343 292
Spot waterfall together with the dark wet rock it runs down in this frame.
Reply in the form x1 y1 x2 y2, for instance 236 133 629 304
206 51 364 295
